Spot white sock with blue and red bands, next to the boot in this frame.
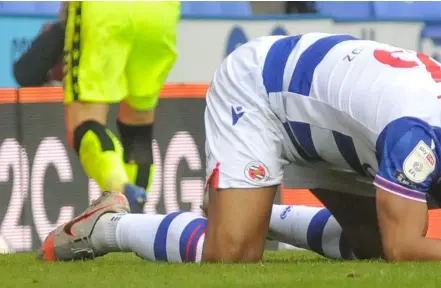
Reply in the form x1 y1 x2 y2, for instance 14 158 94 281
116 212 207 262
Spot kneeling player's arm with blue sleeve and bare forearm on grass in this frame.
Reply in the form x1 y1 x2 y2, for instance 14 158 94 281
374 118 441 261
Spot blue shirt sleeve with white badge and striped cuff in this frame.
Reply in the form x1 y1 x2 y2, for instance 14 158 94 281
374 117 439 202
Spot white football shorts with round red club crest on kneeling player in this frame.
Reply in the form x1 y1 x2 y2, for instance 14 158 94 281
205 39 290 189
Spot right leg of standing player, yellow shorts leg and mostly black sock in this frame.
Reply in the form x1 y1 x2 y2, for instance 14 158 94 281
117 1 180 198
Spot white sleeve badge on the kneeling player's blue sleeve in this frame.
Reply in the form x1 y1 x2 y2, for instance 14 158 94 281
403 141 436 183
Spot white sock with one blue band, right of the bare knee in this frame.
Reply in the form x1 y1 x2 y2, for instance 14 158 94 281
269 205 354 259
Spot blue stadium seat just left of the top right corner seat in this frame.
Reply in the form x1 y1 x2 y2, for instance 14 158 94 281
315 1 373 19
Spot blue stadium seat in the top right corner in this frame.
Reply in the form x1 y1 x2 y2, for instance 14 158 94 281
372 1 441 20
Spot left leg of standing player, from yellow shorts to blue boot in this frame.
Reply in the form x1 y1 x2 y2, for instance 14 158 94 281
63 2 146 213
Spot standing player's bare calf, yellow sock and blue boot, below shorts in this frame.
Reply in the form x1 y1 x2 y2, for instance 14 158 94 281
65 102 146 213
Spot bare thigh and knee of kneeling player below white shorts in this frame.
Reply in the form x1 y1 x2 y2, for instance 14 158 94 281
202 186 277 263
